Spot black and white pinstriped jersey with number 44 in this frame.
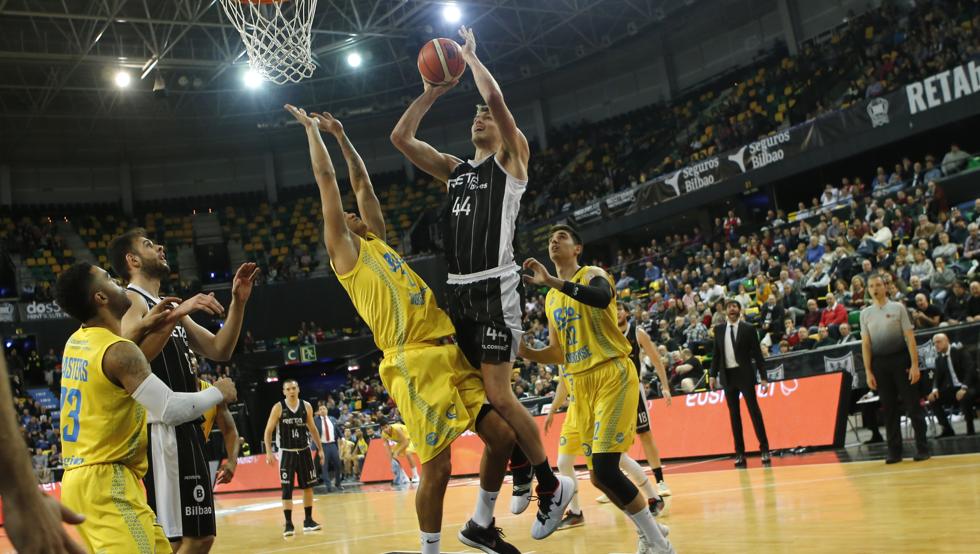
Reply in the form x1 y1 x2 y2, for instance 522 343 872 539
443 156 527 284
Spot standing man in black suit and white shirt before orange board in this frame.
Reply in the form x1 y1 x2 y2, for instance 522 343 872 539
710 300 769 468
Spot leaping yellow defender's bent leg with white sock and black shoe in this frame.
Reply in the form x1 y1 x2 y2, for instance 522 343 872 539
457 404 520 554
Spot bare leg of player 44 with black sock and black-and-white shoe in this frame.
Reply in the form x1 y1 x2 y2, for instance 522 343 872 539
480 362 575 539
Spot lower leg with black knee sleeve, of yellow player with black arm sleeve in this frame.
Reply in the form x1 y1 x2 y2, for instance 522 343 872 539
590 452 674 554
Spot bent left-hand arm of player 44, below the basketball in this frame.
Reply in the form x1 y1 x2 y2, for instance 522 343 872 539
391 82 462 183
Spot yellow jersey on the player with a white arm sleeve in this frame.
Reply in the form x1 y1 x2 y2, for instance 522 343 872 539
61 327 147 477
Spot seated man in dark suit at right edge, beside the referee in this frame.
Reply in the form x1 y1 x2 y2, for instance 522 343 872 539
929 333 977 437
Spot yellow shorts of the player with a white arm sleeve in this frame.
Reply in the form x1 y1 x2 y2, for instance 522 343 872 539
61 464 171 554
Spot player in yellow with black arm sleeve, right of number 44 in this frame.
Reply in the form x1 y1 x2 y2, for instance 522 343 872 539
520 225 673 554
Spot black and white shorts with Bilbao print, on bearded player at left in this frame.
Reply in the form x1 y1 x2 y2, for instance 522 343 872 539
143 422 215 541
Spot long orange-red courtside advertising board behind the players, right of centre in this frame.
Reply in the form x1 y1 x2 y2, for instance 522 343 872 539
361 372 845 483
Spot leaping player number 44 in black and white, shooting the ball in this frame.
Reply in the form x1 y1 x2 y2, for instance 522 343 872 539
391 27 575 539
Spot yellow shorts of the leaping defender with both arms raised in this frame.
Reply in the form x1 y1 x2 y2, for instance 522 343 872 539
379 344 487 464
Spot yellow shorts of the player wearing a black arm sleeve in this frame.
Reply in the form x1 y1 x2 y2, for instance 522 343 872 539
570 358 640 468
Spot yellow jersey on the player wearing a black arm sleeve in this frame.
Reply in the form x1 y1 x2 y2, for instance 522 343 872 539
545 266 632 375
